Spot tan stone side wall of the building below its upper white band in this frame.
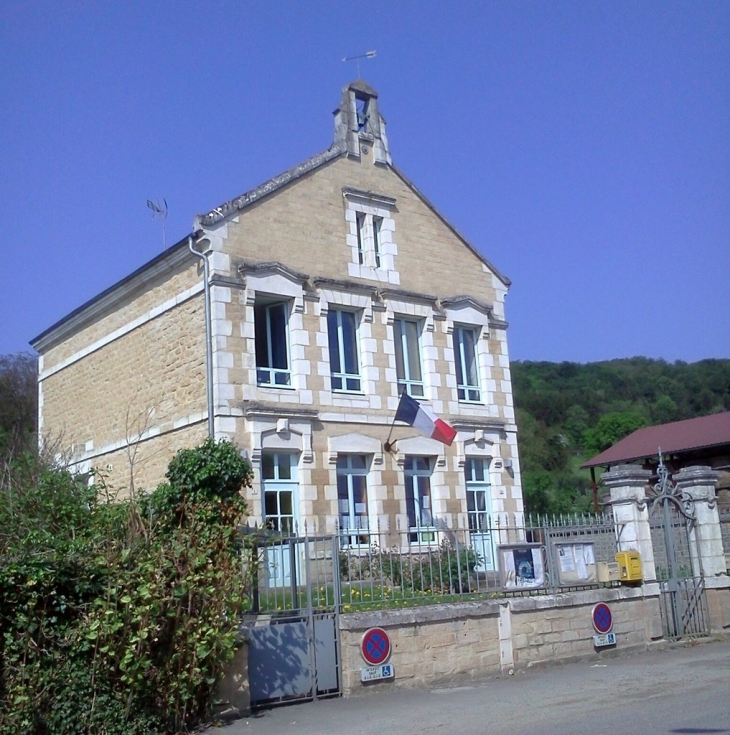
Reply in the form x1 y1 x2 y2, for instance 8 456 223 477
40 295 207 498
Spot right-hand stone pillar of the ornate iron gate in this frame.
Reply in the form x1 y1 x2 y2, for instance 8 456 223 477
672 466 726 577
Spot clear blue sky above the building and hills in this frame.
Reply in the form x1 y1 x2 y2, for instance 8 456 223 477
0 0 730 362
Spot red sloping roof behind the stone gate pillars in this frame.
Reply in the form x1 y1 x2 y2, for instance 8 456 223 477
581 411 730 467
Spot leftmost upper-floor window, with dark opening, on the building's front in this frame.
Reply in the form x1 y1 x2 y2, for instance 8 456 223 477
254 301 291 386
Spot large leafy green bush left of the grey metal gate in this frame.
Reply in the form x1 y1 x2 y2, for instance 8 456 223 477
0 440 251 735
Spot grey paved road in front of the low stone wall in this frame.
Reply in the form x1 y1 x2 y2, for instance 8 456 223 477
208 643 730 735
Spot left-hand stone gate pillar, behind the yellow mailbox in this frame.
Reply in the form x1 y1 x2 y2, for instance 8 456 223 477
601 464 656 581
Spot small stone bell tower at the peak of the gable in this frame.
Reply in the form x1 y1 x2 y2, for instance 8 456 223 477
334 79 392 166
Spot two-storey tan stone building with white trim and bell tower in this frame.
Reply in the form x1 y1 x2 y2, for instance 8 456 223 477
32 81 523 544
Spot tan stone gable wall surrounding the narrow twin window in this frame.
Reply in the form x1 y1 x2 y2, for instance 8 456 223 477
212 158 506 310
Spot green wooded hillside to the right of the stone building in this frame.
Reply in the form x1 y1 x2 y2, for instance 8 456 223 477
512 357 730 513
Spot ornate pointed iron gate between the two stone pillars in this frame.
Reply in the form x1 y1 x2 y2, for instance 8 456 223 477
646 458 710 638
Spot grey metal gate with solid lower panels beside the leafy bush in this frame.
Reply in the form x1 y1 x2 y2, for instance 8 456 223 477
248 535 341 708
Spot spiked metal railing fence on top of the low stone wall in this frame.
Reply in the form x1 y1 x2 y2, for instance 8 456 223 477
245 515 616 615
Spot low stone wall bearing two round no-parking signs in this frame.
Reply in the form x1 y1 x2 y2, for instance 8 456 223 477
340 584 662 696
